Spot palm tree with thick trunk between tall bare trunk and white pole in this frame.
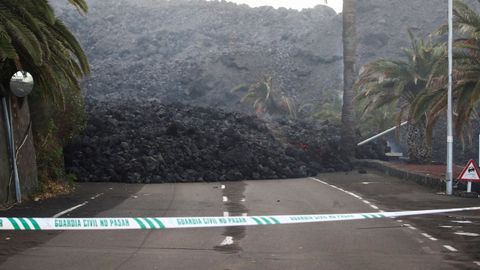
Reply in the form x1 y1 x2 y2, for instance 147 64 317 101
356 30 446 163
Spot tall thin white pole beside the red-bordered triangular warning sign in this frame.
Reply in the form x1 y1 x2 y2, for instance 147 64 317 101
446 0 453 195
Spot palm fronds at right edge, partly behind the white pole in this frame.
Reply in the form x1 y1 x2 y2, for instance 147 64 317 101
412 0 480 138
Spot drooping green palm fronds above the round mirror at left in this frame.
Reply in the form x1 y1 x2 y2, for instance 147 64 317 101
0 0 89 98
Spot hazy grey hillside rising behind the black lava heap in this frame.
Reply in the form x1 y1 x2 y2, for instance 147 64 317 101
50 0 464 109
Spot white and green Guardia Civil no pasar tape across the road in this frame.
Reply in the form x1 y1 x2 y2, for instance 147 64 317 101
0 207 480 231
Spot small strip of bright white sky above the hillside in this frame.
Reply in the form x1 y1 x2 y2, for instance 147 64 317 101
208 0 343 12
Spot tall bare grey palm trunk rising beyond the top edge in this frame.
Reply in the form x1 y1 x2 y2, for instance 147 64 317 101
342 0 357 157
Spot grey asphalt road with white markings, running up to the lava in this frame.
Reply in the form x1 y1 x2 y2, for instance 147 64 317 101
0 174 480 270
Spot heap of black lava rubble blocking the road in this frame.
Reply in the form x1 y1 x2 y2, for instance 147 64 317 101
65 101 352 183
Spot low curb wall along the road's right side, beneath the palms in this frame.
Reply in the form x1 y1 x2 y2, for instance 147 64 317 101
353 159 445 190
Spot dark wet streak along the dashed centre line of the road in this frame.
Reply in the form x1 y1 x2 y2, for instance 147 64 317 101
214 182 248 253
